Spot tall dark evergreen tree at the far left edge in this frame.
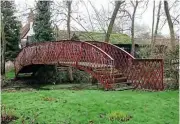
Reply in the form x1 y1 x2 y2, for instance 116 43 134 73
1 1 21 60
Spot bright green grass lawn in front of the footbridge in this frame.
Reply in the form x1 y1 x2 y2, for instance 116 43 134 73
2 90 178 124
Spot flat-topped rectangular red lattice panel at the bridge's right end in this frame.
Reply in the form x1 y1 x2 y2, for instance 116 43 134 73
128 59 164 90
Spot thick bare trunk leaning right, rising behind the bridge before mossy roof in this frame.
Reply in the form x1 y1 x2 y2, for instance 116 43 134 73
105 1 124 43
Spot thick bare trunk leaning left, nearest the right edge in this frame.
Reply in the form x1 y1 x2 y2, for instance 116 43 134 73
164 1 175 50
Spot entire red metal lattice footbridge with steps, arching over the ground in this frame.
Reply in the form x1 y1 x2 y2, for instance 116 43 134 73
15 40 164 91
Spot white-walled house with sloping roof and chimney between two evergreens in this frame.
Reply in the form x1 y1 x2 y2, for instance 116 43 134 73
19 10 34 49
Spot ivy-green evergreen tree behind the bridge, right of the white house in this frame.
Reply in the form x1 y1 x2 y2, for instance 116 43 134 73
33 1 54 42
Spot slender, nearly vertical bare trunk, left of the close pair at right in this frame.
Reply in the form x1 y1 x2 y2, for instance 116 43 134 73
150 0 155 54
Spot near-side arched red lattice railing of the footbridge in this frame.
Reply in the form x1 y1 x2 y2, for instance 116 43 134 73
15 41 114 88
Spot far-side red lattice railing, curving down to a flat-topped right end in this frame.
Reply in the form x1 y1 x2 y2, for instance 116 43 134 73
87 41 164 90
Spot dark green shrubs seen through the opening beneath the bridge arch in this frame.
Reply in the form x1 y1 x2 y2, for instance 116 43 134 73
35 65 92 84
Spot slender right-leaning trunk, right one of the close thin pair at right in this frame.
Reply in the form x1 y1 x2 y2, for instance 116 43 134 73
151 1 161 52
